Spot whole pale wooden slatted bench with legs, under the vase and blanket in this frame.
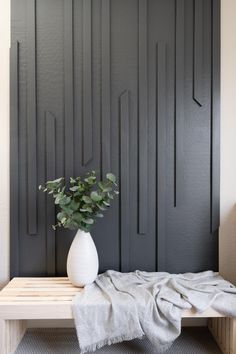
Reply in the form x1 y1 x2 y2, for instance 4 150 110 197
0 277 236 354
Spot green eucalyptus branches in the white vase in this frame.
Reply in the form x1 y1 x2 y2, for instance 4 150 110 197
39 171 119 232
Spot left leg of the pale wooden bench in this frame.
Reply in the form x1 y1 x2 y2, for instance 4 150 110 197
0 319 26 354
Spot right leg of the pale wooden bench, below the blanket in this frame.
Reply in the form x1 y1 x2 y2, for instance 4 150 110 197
208 317 236 354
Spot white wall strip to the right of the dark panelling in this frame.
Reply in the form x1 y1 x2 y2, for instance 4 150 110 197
220 0 236 284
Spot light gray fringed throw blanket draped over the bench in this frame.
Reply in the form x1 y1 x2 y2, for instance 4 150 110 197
73 270 236 353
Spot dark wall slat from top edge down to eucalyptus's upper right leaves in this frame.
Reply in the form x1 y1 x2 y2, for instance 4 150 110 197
101 0 111 178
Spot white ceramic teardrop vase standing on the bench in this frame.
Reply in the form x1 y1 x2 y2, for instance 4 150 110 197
67 230 98 286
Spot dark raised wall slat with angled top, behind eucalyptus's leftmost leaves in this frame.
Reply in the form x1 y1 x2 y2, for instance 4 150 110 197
45 111 56 276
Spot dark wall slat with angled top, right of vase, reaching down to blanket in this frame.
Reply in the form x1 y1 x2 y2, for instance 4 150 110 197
119 90 130 271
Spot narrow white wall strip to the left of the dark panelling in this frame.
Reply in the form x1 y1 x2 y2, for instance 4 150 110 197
0 0 10 286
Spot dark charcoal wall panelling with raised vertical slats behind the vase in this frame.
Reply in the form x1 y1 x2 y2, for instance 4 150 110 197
11 0 220 276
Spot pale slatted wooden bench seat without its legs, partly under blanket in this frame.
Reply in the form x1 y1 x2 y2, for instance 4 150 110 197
0 277 222 319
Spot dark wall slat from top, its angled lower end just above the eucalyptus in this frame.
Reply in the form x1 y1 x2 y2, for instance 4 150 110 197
82 0 93 166
